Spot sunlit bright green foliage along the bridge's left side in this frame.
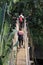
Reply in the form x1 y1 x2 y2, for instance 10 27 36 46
0 21 14 65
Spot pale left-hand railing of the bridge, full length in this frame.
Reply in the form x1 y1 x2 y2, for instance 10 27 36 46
8 20 19 65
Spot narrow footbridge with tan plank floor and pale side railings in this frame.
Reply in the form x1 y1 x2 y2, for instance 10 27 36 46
8 19 34 65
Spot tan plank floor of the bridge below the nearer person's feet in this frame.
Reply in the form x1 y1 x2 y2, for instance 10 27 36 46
17 48 26 65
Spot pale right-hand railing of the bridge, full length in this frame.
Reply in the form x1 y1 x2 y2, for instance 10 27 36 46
24 20 33 65
